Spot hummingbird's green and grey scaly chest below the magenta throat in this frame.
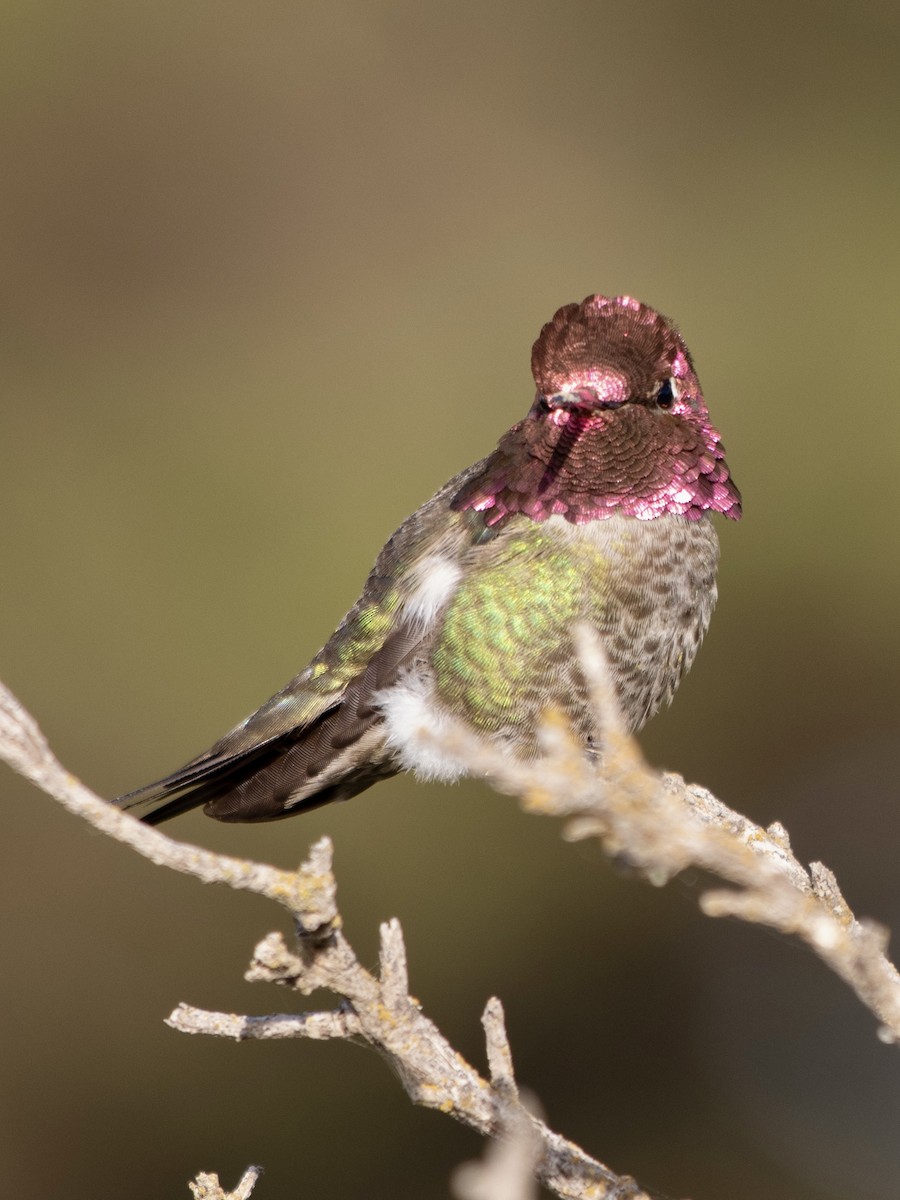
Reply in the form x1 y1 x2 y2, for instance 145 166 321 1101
430 516 715 740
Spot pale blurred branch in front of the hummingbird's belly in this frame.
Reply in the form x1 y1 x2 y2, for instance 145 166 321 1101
403 629 900 1042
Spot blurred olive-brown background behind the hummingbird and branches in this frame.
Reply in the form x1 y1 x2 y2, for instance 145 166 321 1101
0 0 900 1200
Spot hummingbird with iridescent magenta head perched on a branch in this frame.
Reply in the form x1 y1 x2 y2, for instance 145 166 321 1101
116 295 740 824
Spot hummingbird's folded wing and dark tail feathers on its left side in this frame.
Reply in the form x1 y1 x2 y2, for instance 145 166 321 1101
116 468 496 824
